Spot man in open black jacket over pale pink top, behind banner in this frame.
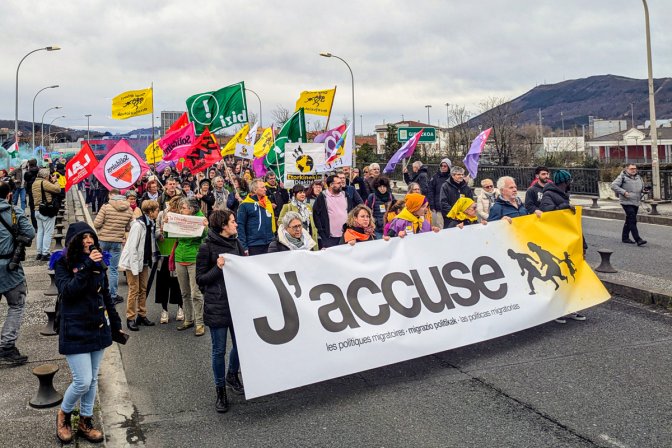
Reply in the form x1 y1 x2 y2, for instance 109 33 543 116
313 174 355 249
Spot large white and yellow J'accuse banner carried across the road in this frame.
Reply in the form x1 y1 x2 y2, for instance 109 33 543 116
223 208 609 399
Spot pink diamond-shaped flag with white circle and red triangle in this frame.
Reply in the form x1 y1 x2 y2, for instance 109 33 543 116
93 139 149 190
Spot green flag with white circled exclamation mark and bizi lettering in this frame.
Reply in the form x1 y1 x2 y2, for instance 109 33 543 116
187 81 247 134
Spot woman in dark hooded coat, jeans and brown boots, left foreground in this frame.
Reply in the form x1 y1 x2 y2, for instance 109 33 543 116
49 222 126 443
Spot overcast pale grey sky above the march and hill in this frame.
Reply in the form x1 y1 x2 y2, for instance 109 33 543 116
0 0 672 133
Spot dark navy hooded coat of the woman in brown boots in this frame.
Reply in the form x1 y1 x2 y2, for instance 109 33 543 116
50 222 121 355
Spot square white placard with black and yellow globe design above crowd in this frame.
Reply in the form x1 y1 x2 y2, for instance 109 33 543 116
285 143 325 189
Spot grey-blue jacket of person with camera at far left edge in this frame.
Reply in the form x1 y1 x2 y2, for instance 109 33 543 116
0 199 35 294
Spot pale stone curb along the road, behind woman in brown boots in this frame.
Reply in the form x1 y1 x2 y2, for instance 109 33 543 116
73 190 145 448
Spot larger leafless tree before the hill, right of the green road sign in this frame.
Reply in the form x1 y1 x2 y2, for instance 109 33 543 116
480 97 518 165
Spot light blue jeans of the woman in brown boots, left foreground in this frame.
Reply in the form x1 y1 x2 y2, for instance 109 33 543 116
61 350 104 417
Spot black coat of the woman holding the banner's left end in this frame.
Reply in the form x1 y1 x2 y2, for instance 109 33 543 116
196 229 244 328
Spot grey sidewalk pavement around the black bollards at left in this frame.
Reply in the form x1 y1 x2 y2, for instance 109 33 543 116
0 192 104 448
